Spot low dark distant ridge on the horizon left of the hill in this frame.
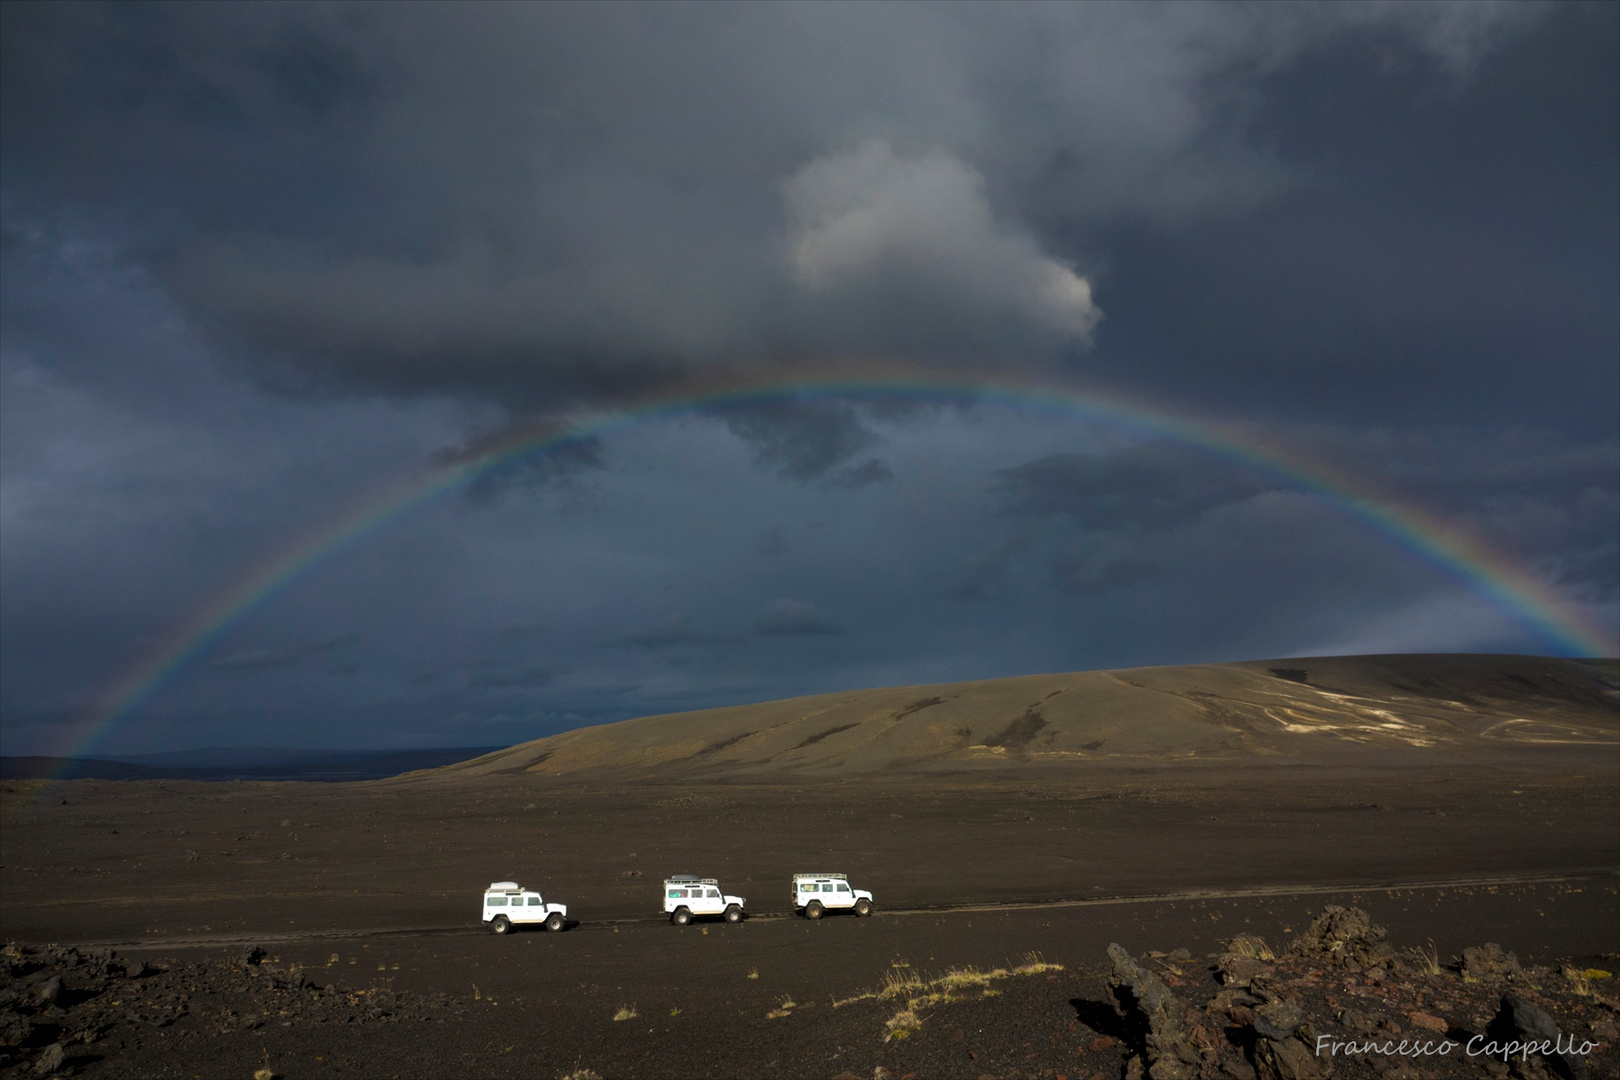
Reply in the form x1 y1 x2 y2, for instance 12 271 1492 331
0 746 501 782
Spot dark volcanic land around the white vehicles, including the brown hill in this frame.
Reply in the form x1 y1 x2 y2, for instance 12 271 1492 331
0 656 1620 1078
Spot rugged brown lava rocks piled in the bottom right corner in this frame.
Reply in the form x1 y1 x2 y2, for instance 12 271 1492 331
1094 907 1620 1080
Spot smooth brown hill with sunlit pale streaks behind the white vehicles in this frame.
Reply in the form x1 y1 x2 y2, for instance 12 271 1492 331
414 654 1620 782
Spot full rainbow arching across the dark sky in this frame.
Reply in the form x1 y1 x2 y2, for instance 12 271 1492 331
58 371 1620 758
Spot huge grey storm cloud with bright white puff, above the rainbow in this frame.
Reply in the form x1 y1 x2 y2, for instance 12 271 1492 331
3 3 1555 414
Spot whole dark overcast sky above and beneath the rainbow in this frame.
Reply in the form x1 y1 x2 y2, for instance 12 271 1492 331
0 0 1620 755
